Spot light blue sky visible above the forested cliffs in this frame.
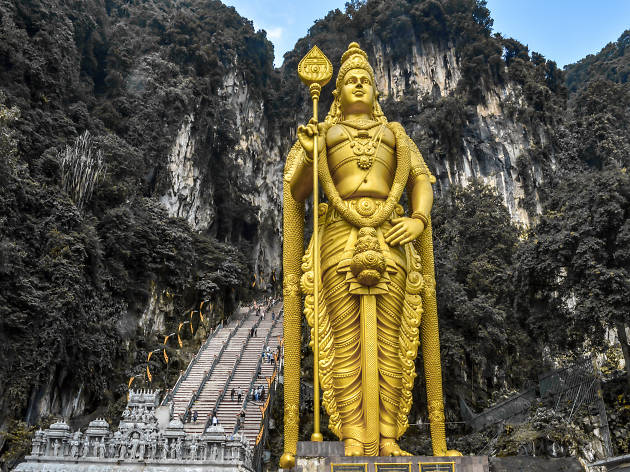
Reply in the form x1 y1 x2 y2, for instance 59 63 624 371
223 0 630 67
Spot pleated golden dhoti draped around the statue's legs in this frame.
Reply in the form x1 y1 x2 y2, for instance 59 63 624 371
304 199 422 455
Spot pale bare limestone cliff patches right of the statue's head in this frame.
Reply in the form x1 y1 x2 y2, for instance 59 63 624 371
370 38 547 224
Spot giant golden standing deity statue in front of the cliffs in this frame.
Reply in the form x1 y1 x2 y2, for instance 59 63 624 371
280 43 459 468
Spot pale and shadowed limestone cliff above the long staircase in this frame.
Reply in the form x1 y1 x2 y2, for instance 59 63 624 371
160 65 286 288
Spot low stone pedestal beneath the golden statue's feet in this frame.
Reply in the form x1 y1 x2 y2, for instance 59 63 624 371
292 441 490 472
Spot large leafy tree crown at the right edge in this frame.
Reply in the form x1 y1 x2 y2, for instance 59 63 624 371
516 169 630 384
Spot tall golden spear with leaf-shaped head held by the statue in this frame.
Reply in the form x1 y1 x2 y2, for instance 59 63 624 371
298 46 333 441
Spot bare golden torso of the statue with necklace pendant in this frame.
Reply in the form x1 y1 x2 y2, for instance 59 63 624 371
326 122 396 199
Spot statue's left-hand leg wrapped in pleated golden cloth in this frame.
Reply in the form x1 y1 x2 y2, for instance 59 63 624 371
322 222 365 455
